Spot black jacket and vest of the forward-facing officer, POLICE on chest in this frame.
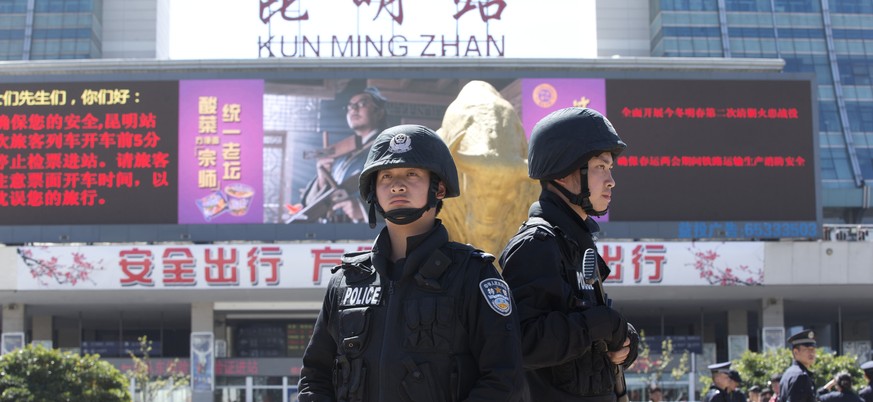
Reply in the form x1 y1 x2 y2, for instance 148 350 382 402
299 220 524 402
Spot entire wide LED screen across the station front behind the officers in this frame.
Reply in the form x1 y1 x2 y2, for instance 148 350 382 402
0 72 818 238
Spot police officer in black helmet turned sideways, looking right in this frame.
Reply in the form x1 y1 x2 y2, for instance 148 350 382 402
500 107 639 402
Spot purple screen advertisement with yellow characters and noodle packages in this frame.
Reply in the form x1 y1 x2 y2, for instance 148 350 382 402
179 80 264 223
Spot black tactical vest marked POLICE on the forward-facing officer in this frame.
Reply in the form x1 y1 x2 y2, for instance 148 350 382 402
330 243 494 402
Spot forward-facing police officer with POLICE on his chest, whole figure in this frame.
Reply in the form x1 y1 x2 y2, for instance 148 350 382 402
299 125 525 402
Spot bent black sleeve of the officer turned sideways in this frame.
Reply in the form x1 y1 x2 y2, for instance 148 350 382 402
501 236 613 370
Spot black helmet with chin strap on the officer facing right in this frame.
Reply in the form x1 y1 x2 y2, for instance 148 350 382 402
527 107 627 216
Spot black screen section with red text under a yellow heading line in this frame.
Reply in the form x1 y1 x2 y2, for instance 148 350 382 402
0 82 178 225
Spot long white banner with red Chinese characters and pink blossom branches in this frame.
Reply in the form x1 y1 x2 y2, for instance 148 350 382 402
17 242 764 290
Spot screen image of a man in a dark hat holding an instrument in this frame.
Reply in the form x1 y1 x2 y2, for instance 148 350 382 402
264 78 520 225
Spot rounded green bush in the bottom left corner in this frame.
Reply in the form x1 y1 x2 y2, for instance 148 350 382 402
0 345 130 402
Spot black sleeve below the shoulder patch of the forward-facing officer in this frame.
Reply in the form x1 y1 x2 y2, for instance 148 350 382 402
463 257 525 401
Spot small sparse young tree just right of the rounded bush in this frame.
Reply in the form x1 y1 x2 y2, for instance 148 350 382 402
127 336 189 402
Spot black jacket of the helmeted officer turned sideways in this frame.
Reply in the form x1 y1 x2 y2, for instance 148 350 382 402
500 191 637 402
